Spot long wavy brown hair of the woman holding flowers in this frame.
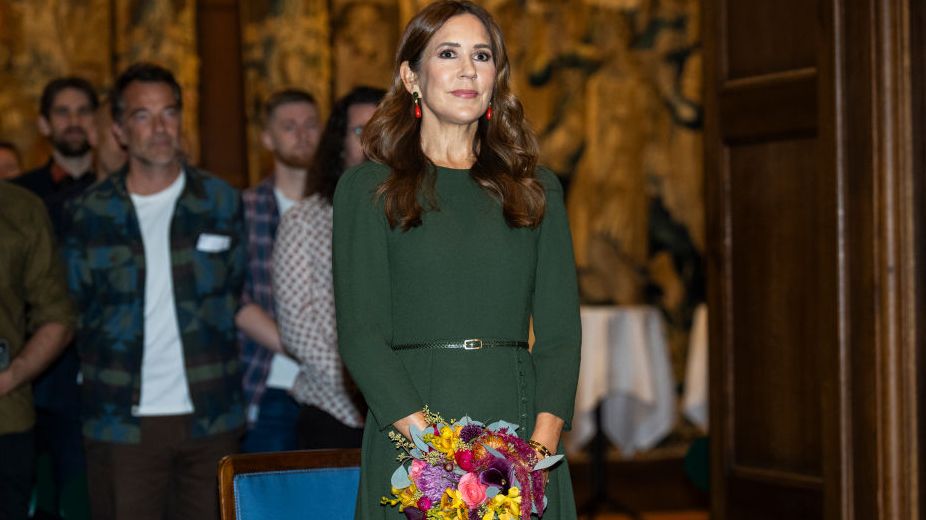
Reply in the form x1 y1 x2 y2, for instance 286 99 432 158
363 0 546 230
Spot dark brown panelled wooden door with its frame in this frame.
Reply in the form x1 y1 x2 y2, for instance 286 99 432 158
704 0 926 520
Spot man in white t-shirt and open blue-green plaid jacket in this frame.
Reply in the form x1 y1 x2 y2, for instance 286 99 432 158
64 63 246 520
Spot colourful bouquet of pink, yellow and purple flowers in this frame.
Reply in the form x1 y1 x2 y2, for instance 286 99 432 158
380 407 563 520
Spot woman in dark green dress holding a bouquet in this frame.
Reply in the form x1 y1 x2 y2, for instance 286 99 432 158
333 1 581 520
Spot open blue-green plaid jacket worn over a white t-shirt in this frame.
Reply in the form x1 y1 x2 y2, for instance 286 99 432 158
63 166 247 443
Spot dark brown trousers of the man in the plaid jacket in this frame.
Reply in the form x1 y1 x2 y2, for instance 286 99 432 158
86 415 241 520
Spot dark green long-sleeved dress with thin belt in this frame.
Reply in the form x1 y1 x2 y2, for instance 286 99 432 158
333 163 581 520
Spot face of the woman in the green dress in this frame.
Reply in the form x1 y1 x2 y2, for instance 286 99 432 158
406 14 495 125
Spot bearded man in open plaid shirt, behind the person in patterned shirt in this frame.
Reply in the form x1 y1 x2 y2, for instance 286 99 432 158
235 89 322 452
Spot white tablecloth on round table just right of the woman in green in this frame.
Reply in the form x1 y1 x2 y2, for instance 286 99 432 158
564 306 676 455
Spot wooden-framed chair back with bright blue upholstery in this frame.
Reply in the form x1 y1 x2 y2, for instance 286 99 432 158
219 449 360 520
